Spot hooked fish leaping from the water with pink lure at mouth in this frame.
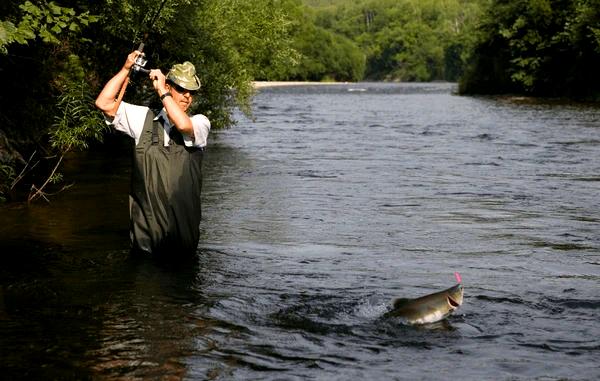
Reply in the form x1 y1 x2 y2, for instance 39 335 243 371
384 273 464 325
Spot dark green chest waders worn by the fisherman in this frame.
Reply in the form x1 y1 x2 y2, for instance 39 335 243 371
129 111 203 255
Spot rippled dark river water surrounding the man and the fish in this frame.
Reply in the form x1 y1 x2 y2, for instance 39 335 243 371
0 83 600 380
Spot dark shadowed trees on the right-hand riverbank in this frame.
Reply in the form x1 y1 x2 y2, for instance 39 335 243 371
461 0 600 97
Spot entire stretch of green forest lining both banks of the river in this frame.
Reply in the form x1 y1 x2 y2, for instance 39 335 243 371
0 0 600 200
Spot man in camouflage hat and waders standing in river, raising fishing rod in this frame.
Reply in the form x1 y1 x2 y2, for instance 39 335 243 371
96 51 210 254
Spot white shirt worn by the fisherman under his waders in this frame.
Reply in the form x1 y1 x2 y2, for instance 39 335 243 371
107 102 210 148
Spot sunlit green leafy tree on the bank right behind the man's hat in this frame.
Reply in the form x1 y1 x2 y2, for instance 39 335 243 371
172 0 296 128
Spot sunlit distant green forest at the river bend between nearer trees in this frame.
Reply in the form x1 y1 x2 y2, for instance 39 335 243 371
280 0 487 81
